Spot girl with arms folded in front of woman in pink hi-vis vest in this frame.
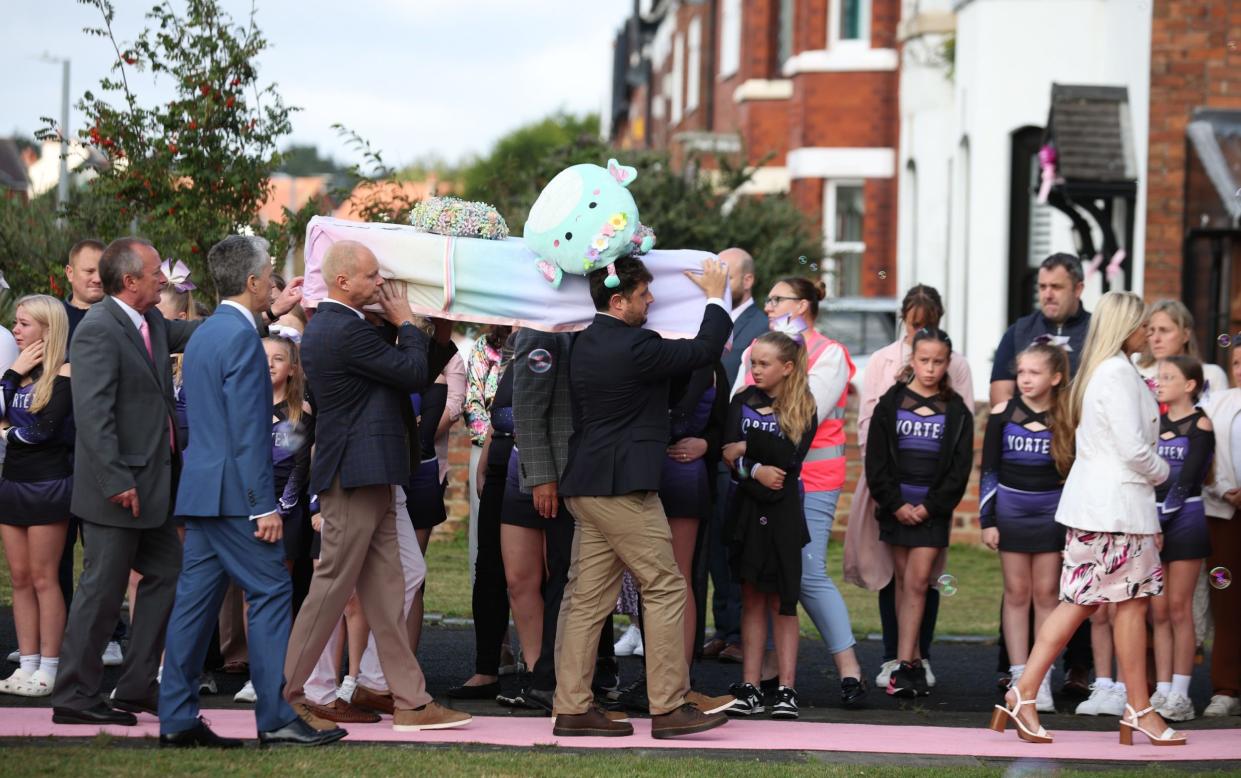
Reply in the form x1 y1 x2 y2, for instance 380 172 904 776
724 333 818 718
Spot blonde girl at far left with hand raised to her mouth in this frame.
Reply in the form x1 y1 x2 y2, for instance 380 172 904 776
0 294 73 697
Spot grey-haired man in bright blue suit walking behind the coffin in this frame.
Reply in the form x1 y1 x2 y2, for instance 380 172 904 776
159 236 345 748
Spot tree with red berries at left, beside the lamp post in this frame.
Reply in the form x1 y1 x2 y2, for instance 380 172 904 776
41 0 294 299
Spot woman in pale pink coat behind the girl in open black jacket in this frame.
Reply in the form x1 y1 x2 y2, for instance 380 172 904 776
845 284 974 689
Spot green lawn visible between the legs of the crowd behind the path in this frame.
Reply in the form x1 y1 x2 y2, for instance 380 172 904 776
0 530 1003 638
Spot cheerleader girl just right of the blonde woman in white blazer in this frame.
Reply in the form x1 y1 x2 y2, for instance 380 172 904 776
1150 356 1215 721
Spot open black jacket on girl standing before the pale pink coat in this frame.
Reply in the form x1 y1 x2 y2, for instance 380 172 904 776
866 382 974 521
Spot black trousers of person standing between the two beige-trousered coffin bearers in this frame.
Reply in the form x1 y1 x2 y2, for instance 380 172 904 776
472 451 513 675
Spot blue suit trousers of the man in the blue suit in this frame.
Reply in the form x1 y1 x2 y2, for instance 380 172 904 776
159 516 297 735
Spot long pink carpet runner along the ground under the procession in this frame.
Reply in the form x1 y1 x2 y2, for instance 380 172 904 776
0 707 1241 762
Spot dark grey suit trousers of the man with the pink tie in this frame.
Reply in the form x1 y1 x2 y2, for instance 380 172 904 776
52 521 181 710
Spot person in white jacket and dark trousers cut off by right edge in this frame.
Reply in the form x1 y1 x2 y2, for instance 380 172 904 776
1203 347 1241 717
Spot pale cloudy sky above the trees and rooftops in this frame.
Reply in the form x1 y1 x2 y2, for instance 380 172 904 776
0 0 620 165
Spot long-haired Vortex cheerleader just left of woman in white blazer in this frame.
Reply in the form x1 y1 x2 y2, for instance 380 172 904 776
979 344 1073 712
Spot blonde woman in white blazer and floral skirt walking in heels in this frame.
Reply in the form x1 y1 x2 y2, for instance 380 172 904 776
992 292 1185 746
